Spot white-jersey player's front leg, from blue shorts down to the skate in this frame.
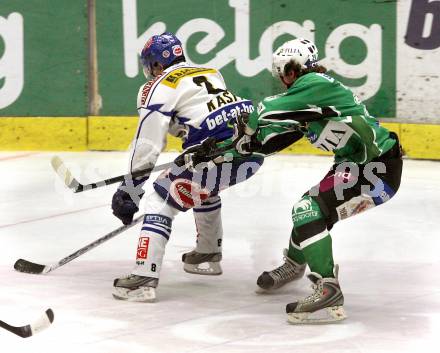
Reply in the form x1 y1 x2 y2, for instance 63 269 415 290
113 153 263 302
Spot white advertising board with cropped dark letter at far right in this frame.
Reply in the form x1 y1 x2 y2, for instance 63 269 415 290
396 0 440 124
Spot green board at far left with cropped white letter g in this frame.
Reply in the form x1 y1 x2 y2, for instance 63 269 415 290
0 0 88 116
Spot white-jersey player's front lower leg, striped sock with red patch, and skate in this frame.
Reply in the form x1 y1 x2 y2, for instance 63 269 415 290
113 192 179 302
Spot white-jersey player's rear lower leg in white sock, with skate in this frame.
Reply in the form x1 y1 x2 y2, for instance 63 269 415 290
182 195 223 275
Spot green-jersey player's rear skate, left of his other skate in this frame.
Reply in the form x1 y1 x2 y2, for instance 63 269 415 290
256 249 306 293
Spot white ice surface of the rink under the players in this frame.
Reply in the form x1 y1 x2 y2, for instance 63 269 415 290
0 152 440 353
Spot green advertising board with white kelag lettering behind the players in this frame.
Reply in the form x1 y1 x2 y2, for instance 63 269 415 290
97 0 396 116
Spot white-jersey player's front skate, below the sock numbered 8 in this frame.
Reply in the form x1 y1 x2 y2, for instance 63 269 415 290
112 275 159 302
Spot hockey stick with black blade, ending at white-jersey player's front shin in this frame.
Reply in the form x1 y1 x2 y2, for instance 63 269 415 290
14 215 144 274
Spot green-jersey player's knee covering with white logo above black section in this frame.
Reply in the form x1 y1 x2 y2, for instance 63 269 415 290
292 195 327 246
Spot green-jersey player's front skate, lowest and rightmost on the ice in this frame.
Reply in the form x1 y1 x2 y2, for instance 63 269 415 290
286 265 347 324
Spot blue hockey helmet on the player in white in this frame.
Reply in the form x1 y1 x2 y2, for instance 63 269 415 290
141 32 185 77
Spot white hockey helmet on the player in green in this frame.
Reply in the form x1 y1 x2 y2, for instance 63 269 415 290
272 38 318 77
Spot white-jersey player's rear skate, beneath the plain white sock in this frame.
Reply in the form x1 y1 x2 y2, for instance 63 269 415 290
182 250 223 276
